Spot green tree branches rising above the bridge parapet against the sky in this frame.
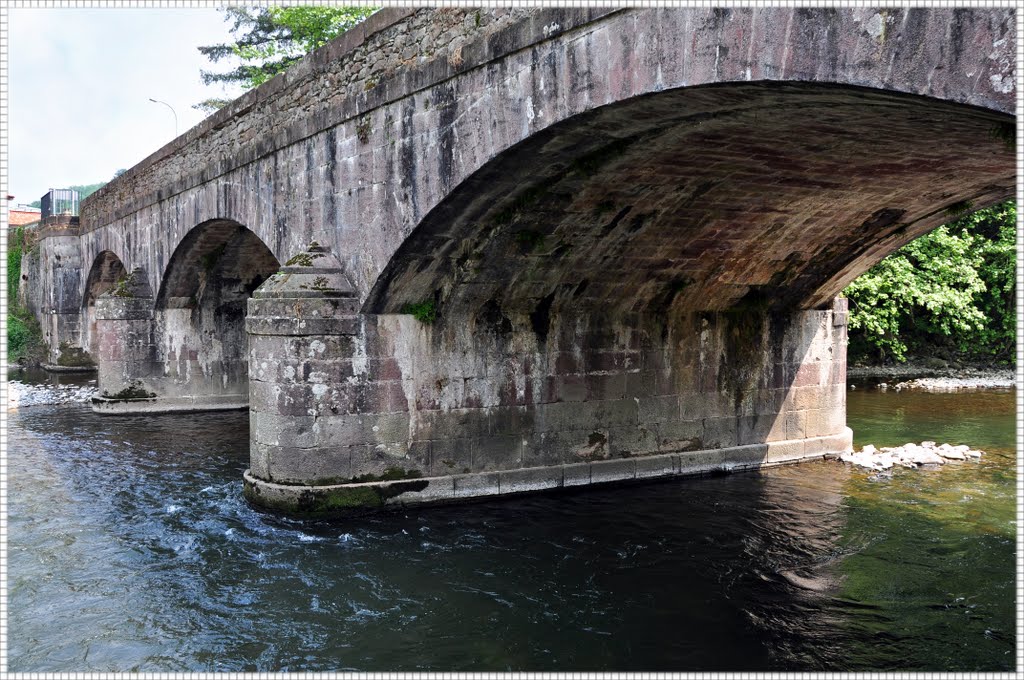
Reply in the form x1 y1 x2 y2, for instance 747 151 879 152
196 6 376 99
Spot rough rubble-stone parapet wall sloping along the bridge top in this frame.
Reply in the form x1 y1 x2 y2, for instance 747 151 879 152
76 7 569 231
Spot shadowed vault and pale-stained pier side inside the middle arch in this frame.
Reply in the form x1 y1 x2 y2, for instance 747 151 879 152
154 219 280 407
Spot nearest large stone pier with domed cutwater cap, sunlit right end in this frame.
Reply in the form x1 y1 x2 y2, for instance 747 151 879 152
245 244 851 515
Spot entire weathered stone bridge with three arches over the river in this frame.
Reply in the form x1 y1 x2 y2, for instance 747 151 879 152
24 8 1017 513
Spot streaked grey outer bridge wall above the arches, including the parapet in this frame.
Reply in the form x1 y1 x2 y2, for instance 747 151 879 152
74 7 1016 302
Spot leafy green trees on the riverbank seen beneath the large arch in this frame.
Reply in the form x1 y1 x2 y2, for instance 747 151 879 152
844 202 1017 363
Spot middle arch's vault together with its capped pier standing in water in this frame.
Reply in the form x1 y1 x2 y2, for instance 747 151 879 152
95 218 280 413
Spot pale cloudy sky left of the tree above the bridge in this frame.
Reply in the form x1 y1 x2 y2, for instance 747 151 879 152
4 7 238 204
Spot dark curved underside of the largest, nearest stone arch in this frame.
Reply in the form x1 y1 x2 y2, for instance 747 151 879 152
362 81 1016 320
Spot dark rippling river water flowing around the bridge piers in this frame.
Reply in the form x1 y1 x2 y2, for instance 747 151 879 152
6 378 1016 672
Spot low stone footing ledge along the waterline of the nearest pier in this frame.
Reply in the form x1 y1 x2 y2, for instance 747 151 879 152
243 427 853 517
